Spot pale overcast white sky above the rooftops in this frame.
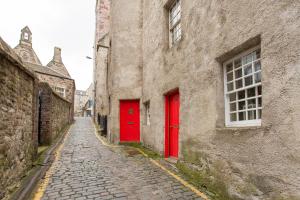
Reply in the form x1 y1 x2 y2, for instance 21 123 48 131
0 0 95 90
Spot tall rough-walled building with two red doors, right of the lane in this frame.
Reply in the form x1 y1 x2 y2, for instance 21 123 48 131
94 0 300 199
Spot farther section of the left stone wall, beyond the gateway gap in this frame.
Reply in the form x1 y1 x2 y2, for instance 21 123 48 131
39 82 72 145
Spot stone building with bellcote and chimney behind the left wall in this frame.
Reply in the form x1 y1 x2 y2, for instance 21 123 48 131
14 26 75 116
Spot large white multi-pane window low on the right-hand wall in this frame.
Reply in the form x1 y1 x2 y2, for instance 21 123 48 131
224 47 262 126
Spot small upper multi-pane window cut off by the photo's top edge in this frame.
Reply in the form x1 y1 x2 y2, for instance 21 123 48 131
169 0 181 46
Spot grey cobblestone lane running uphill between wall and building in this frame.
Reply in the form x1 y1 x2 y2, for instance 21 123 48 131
42 118 201 200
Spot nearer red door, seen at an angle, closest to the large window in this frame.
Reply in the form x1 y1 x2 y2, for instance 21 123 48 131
165 92 180 158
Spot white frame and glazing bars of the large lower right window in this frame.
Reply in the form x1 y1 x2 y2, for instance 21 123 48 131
223 46 263 127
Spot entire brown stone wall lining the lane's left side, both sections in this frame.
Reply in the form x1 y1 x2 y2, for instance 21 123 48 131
0 37 74 199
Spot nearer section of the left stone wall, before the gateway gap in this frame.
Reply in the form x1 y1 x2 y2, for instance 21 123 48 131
0 37 37 199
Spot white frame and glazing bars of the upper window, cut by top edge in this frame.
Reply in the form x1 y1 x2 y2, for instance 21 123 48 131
168 0 182 47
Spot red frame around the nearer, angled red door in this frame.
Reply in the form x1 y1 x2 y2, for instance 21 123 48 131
164 88 180 158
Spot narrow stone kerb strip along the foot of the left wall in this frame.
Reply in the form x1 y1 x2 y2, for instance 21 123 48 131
10 124 72 200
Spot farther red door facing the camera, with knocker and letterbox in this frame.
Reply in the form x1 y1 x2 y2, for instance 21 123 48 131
120 100 140 142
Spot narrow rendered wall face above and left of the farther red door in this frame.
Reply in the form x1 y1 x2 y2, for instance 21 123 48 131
108 0 143 142
